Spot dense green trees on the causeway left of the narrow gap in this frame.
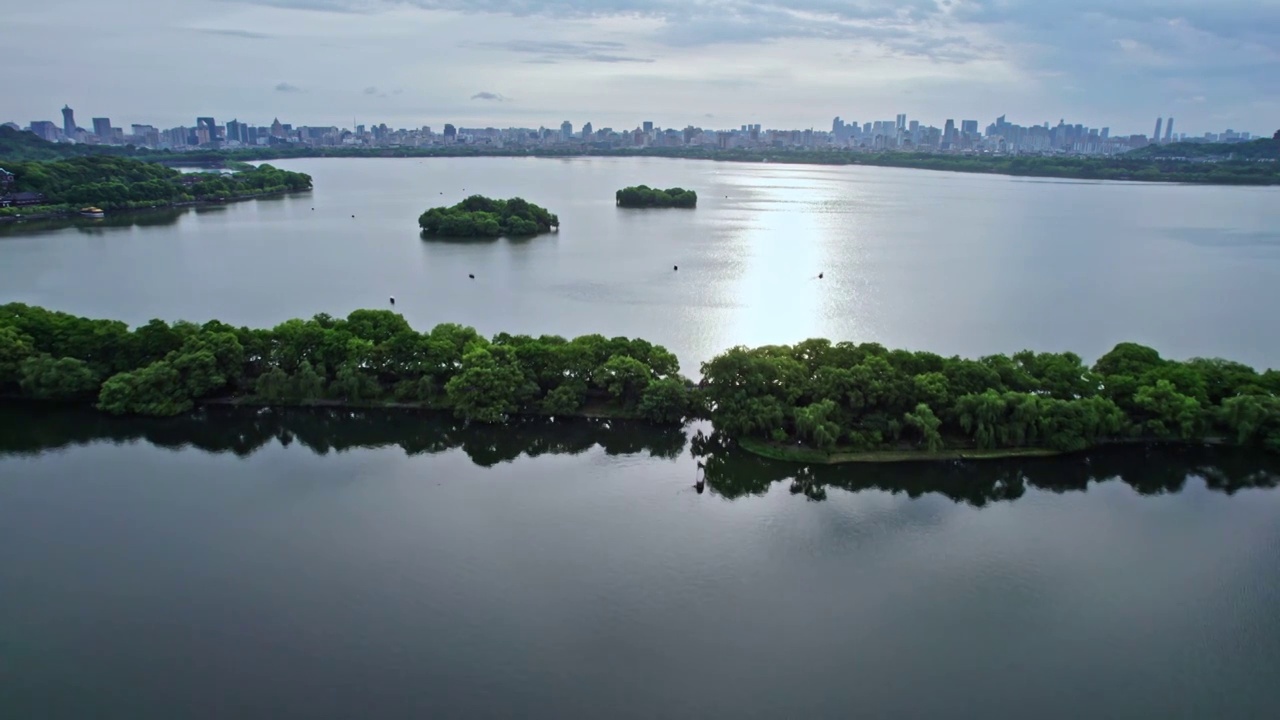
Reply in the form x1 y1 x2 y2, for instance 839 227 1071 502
0 304 694 423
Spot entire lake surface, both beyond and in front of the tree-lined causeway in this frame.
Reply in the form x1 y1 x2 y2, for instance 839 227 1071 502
0 159 1280 720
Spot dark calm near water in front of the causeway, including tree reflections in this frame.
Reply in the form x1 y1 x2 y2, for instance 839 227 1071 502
0 409 1280 719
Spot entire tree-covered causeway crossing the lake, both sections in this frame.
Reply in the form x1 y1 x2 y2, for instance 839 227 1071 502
0 304 1280 464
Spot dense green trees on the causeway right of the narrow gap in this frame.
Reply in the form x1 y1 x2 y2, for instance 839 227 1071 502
703 340 1280 452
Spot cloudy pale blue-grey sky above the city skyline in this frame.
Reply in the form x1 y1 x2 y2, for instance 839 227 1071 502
0 0 1280 135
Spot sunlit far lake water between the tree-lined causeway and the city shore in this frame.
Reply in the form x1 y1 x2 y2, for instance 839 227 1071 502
0 159 1280 374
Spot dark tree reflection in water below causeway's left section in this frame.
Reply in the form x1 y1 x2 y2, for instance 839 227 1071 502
0 404 687 468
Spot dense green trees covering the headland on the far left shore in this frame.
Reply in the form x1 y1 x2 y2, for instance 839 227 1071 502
5 155 311 213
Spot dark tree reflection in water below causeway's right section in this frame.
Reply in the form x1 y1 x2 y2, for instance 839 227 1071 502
690 433 1280 507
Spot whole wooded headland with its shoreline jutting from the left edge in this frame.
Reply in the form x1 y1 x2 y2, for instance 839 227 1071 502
0 155 311 219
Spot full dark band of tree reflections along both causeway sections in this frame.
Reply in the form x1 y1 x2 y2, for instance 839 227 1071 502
0 404 1280 507
